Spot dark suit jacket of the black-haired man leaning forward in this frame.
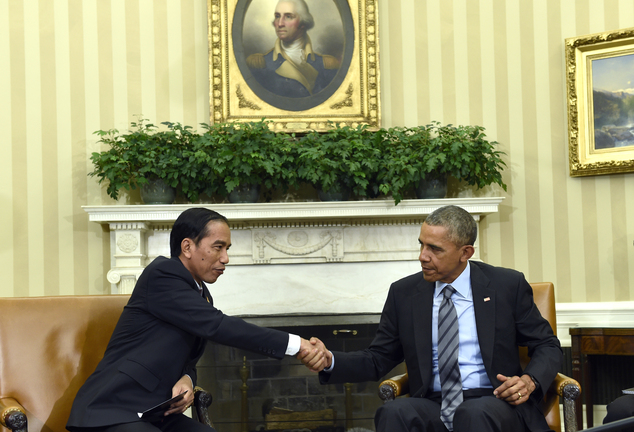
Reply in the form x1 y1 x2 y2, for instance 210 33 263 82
67 257 288 430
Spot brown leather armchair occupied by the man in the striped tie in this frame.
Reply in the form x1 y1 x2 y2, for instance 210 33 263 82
379 282 581 432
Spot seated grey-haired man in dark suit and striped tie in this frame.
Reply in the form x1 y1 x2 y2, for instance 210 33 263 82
300 206 562 432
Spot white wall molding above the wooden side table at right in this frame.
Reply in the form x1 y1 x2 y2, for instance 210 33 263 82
555 301 634 347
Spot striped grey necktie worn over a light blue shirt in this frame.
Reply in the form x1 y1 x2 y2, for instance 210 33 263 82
438 285 462 431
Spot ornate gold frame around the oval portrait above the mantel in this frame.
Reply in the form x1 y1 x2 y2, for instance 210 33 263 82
207 0 381 132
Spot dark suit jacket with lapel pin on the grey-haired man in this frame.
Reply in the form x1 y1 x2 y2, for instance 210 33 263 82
320 261 562 431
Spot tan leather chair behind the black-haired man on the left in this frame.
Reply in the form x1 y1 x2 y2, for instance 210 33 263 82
0 295 211 432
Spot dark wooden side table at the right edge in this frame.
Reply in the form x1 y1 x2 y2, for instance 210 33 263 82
569 327 634 430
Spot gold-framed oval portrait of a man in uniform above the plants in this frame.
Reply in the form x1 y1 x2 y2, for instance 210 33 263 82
207 0 381 132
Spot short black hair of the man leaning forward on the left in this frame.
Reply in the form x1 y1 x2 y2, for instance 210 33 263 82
170 207 229 257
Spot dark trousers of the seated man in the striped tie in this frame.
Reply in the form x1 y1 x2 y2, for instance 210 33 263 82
374 389 525 432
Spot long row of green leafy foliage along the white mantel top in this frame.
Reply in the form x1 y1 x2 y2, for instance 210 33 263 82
89 119 506 204
